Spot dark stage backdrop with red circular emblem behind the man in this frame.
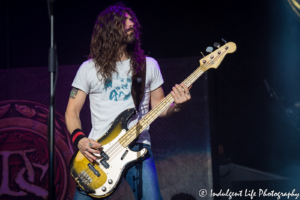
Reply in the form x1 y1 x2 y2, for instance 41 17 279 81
0 57 212 200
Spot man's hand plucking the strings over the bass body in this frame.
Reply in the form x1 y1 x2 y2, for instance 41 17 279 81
78 138 102 162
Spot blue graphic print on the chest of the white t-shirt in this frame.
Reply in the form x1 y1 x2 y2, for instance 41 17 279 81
103 74 131 101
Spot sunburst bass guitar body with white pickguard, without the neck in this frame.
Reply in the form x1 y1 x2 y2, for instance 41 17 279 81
70 108 147 198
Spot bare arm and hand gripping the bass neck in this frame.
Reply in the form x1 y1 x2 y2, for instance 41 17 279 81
150 84 191 117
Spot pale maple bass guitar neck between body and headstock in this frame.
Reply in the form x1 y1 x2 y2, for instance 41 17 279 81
119 66 207 147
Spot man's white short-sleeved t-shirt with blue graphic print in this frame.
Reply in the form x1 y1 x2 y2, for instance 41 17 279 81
72 57 164 144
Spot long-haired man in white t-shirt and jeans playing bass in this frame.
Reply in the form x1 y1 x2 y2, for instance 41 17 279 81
65 3 191 200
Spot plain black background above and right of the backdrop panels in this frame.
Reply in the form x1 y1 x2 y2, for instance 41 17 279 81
0 0 300 178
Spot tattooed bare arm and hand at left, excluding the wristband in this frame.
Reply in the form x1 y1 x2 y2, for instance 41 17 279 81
65 88 101 162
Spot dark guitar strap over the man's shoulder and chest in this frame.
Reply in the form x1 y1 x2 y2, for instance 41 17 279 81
131 65 146 112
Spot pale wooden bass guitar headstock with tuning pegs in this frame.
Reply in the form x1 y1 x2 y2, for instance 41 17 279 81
199 42 236 70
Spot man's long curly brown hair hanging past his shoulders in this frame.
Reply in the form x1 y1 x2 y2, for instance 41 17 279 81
89 3 146 83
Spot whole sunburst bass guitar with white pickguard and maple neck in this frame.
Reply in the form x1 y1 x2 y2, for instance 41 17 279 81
70 42 236 198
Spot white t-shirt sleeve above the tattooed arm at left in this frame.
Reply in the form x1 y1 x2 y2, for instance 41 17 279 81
72 62 90 94
